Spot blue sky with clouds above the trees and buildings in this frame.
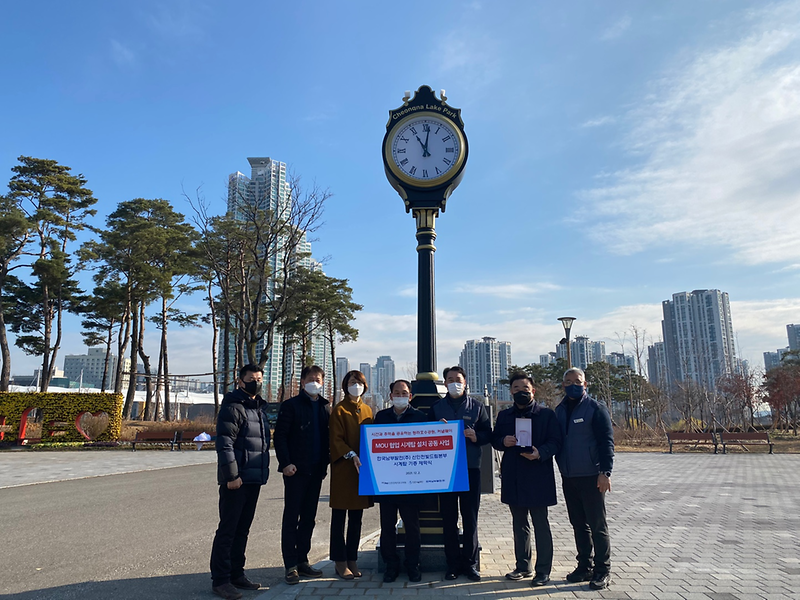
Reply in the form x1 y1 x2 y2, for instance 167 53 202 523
0 0 800 375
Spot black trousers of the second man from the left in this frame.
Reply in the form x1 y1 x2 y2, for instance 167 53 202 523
281 473 324 569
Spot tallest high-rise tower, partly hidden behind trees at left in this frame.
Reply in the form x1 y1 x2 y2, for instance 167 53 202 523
219 157 330 400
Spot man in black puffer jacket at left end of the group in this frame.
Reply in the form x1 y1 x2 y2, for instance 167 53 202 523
211 365 270 600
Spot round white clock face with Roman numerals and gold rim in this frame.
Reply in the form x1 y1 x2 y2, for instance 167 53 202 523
386 114 464 187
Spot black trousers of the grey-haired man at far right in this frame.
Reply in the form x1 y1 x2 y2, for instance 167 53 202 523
561 475 611 574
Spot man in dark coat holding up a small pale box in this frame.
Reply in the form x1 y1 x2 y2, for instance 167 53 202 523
492 372 562 586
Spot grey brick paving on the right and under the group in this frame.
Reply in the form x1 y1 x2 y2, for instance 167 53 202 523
255 452 800 600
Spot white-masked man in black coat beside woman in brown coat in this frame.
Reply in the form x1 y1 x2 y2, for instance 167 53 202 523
275 365 330 585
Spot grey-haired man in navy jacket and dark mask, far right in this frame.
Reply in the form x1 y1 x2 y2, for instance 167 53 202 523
556 368 614 590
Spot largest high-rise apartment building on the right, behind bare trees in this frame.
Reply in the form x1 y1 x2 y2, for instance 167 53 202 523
661 290 739 390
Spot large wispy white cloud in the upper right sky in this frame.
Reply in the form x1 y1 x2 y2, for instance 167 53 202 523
581 3 800 264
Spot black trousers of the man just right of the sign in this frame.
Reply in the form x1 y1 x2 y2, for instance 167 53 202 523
439 469 481 571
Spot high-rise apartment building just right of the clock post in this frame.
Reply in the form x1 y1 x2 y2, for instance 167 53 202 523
458 337 512 402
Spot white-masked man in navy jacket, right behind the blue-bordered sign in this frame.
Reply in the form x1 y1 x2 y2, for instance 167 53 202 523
429 366 492 581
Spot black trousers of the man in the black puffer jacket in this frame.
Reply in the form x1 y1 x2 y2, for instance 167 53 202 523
211 484 261 586
